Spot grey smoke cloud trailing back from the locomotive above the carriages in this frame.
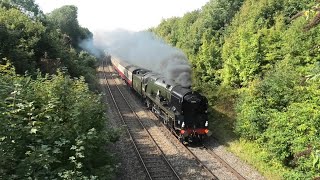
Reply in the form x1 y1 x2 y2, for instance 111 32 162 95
85 30 191 87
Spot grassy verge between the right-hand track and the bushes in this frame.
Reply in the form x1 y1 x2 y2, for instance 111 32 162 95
209 95 289 180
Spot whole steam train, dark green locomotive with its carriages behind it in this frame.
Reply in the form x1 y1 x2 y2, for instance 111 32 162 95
111 57 209 143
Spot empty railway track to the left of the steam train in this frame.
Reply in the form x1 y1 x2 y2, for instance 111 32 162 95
103 61 180 179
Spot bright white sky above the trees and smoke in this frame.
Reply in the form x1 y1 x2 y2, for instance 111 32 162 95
35 0 209 32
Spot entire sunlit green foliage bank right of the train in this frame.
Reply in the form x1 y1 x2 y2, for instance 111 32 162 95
151 0 320 179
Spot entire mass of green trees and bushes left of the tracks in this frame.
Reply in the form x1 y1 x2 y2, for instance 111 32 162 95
0 0 117 179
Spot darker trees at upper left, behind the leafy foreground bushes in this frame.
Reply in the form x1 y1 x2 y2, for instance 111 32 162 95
0 0 97 86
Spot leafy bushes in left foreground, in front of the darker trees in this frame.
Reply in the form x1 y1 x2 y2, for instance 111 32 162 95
0 64 114 179
